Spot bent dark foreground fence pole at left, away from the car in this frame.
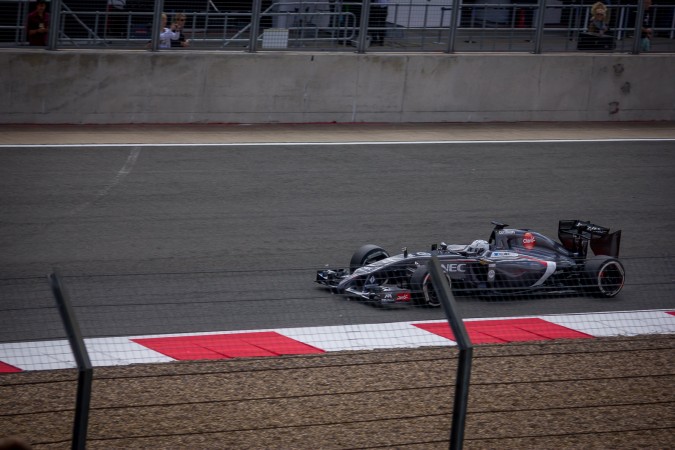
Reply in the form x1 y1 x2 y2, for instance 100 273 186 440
49 271 93 450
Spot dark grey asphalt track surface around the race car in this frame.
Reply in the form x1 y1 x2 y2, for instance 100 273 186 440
0 140 675 342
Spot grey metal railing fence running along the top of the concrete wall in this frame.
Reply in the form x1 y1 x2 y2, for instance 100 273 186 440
0 0 675 53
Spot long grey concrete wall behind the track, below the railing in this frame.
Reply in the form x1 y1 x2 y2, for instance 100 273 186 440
0 49 675 124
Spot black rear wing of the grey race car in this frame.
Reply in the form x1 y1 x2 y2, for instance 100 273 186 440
558 219 621 258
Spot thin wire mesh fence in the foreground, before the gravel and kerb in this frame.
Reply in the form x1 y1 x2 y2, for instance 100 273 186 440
0 258 675 448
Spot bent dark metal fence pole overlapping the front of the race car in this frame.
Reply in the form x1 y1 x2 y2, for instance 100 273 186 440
427 256 473 450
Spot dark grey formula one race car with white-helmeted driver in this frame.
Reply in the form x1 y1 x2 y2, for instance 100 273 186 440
316 220 625 306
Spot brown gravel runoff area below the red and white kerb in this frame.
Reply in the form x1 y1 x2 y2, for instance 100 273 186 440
0 335 675 449
